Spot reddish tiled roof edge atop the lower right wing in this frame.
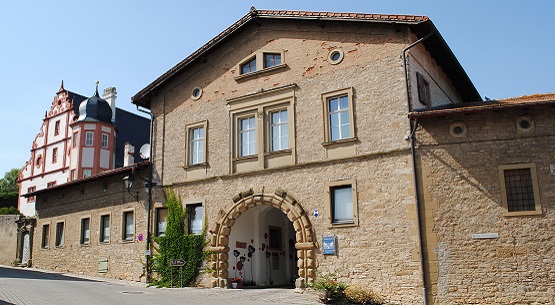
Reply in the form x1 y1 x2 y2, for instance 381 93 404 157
409 93 555 118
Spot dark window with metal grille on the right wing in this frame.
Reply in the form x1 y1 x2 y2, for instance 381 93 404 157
504 168 536 212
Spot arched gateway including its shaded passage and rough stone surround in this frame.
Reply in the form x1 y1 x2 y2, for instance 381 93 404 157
210 189 315 287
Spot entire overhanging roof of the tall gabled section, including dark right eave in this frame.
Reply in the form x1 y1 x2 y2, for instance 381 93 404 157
131 7 482 108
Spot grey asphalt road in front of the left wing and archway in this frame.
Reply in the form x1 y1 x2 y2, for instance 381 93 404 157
0 266 321 305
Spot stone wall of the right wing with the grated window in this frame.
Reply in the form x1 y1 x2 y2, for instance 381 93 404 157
416 95 555 304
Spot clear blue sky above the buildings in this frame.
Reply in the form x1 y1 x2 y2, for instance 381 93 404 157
0 0 555 177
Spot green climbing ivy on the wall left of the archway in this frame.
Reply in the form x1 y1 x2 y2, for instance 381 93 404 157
151 189 209 287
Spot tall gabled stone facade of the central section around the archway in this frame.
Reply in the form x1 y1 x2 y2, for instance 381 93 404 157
135 10 476 304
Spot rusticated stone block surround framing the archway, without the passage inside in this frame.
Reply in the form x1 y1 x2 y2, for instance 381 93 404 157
209 189 315 288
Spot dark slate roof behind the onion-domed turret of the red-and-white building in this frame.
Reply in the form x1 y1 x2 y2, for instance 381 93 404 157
115 107 150 168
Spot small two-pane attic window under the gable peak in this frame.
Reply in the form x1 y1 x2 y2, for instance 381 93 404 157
235 51 285 80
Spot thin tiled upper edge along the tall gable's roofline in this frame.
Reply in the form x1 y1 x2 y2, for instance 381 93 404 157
131 7 428 106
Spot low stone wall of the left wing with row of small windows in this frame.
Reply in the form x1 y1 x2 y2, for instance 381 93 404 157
33 167 153 281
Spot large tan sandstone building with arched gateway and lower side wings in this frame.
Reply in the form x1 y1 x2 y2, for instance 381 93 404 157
30 9 555 304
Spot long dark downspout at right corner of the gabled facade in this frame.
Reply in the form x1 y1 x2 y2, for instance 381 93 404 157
403 27 436 305
